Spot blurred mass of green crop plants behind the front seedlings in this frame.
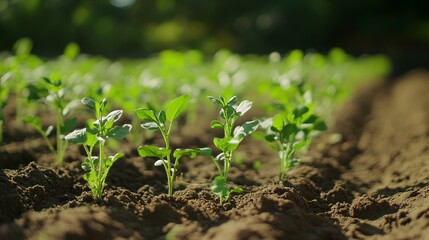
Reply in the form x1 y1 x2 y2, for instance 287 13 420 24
0 39 390 145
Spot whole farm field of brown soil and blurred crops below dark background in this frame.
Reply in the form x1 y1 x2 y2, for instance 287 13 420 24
0 40 429 240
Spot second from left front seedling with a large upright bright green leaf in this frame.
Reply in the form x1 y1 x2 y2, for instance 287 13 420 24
135 95 211 196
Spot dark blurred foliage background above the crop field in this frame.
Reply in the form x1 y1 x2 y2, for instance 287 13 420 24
0 0 429 73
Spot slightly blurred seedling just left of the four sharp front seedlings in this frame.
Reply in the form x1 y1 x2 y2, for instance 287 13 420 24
23 78 77 165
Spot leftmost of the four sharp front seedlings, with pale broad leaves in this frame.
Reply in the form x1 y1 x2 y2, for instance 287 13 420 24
65 98 131 199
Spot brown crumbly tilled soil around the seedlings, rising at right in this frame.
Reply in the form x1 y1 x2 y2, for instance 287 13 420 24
0 71 429 240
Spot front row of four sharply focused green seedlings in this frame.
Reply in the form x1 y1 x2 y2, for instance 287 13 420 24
64 95 326 204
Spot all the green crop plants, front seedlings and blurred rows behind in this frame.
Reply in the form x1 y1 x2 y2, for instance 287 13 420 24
0 39 389 203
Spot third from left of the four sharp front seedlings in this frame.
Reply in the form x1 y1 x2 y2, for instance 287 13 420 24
208 96 259 204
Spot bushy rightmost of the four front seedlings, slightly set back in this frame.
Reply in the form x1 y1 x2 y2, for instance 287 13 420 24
261 105 326 182
